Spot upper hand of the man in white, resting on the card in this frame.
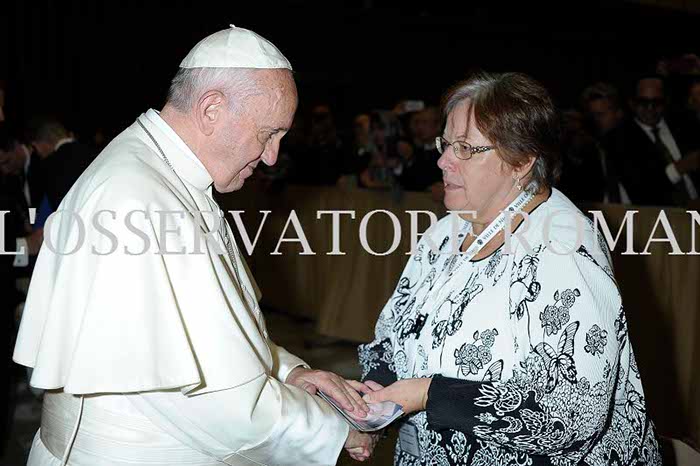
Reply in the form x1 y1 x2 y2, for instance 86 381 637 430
286 367 372 418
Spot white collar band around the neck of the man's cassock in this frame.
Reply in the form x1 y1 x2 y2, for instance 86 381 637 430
139 109 214 191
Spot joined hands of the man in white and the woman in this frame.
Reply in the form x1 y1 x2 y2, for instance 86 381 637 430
286 367 431 461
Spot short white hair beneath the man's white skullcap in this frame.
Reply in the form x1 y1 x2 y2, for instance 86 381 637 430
166 68 260 112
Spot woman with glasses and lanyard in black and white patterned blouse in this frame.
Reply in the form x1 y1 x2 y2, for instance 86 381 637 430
360 73 660 466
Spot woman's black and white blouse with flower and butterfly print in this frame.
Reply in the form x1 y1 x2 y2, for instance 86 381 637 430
359 190 661 466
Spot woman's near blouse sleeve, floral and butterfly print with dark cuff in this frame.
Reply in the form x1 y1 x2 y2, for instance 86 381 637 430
426 245 658 465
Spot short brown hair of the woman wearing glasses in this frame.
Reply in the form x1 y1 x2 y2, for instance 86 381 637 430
443 72 561 190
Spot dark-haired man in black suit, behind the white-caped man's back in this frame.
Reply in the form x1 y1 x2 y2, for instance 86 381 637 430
28 117 95 210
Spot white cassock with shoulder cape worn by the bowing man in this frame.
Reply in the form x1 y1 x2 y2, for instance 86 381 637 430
14 110 348 466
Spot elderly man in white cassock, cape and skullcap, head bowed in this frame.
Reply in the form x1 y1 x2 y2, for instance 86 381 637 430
14 26 372 466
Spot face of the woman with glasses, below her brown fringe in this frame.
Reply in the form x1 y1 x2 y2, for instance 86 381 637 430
438 100 518 221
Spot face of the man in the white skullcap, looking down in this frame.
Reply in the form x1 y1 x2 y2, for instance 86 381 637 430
212 70 297 193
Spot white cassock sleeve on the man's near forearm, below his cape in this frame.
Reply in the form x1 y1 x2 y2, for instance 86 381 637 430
129 375 349 466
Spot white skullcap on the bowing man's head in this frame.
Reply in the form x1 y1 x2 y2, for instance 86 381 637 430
180 24 292 70
